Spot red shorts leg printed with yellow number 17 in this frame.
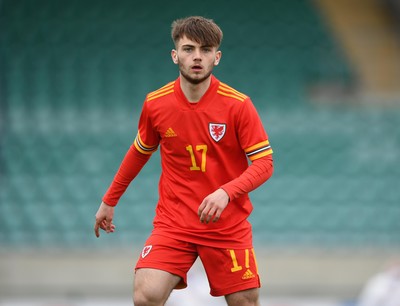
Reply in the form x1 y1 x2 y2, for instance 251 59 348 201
198 246 260 296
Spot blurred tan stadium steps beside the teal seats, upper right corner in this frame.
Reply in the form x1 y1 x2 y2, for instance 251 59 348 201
315 0 400 99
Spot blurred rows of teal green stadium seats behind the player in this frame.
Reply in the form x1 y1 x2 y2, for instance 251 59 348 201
0 0 400 247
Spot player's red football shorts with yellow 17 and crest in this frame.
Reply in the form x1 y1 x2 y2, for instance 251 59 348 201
135 235 260 296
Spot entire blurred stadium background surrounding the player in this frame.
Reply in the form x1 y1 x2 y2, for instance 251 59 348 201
0 0 400 306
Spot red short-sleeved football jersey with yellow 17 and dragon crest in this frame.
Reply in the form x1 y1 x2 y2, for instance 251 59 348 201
134 76 272 248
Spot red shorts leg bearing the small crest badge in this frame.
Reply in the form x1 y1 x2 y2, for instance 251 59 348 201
135 235 197 289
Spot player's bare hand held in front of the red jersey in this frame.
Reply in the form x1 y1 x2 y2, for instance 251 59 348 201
198 188 229 223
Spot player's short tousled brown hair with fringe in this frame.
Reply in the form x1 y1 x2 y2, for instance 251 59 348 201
171 16 223 48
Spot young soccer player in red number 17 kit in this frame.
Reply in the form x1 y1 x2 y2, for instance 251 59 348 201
94 16 273 306
